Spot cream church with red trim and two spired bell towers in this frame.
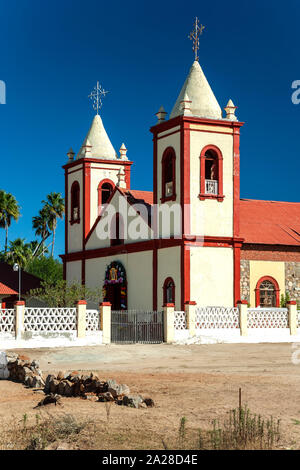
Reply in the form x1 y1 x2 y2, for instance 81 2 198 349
62 57 300 310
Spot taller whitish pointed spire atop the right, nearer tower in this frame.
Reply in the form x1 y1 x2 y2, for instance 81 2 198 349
170 60 222 119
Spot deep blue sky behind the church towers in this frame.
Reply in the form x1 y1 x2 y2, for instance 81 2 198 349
0 0 300 256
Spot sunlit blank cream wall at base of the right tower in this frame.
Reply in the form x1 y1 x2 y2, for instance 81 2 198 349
190 247 234 307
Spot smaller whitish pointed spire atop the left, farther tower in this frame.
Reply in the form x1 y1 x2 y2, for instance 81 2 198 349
76 114 117 160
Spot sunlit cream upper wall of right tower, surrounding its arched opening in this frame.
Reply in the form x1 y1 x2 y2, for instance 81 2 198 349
190 124 233 237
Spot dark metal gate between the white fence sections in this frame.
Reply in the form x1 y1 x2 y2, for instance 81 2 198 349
111 310 164 343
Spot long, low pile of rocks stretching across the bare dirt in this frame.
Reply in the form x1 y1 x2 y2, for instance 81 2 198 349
44 371 154 408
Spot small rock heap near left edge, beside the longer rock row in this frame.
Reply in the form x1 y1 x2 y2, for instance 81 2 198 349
6 353 45 388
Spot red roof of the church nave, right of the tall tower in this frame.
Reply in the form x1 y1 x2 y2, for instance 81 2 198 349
240 199 300 246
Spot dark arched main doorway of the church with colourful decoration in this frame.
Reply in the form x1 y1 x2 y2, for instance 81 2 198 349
103 261 127 310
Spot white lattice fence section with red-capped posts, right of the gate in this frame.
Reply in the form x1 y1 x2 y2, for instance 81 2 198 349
174 300 300 342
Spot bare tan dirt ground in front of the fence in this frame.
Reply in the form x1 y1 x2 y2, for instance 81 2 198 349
0 344 300 449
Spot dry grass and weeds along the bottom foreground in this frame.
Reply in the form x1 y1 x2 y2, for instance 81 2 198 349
0 406 280 450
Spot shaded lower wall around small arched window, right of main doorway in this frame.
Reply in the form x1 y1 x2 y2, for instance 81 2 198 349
157 246 181 310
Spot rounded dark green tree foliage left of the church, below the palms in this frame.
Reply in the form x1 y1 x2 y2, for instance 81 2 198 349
26 256 63 285
